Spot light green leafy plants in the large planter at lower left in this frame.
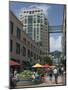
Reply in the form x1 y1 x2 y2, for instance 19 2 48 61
19 70 32 80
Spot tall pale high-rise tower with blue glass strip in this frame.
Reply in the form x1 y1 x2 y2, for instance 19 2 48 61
19 8 48 54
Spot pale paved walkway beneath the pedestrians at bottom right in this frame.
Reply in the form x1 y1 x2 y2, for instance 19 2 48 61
16 76 63 88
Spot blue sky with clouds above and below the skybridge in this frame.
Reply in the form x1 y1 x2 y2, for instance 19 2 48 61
9 2 64 52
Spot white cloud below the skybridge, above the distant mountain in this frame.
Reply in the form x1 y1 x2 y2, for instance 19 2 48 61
50 36 61 52
